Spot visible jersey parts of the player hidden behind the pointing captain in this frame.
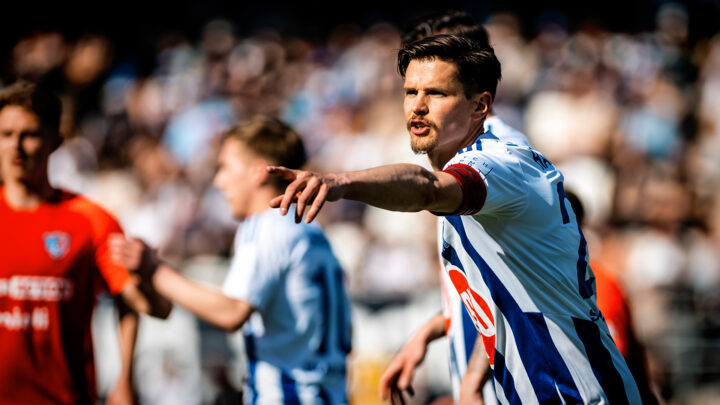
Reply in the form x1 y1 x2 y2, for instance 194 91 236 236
438 116 530 405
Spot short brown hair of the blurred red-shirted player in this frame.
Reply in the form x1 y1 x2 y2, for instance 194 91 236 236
0 80 62 136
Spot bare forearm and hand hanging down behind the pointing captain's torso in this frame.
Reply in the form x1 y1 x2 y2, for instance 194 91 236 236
380 314 445 404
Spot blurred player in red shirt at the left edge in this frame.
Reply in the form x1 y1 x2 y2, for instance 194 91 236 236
0 82 170 404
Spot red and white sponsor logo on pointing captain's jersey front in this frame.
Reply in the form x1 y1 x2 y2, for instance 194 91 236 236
448 268 495 365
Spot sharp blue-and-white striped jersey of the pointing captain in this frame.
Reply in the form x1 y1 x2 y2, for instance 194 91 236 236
439 132 640 404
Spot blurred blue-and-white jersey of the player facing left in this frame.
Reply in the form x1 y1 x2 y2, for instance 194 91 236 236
223 210 351 405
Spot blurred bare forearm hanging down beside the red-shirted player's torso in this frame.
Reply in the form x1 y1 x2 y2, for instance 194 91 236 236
106 300 139 405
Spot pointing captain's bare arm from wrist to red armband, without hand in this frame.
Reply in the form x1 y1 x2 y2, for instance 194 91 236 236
337 164 462 212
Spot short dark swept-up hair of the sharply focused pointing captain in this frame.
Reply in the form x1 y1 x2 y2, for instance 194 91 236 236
398 34 501 99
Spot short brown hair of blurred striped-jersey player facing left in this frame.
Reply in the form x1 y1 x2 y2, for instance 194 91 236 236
225 115 307 169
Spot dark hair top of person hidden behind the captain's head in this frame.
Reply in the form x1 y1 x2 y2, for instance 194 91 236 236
402 10 490 47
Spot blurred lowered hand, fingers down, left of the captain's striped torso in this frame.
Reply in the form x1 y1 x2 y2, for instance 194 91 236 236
380 337 427 405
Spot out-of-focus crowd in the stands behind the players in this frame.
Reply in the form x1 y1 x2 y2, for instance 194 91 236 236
0 0 720 404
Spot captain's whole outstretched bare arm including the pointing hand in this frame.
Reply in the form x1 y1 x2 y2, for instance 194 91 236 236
268 164 463 222
